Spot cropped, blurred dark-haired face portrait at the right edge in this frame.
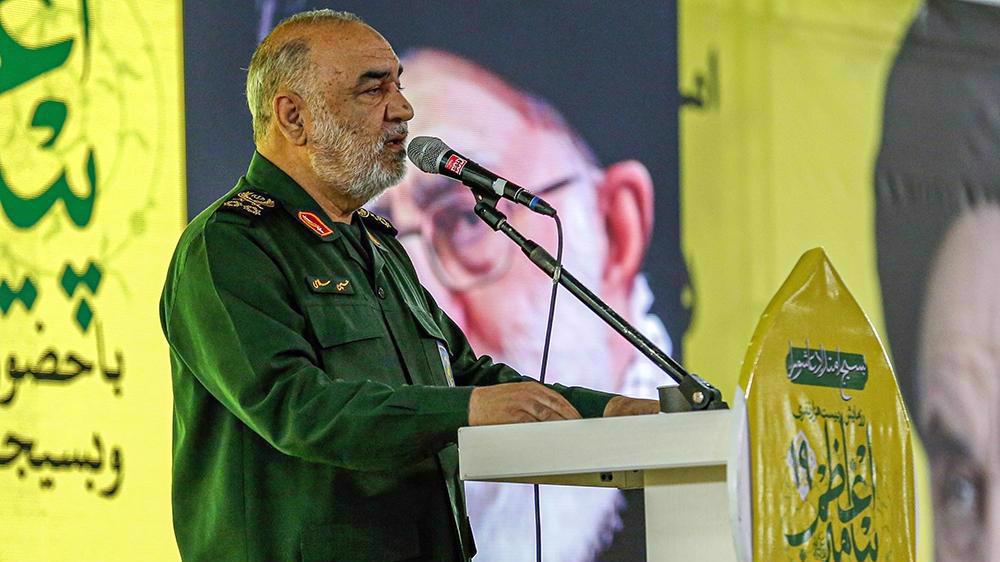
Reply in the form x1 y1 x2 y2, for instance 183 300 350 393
874 1 1000 562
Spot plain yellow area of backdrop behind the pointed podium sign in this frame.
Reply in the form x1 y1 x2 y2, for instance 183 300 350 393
677 0 933 561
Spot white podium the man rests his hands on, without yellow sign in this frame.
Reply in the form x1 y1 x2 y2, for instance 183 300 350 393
458 410 738 562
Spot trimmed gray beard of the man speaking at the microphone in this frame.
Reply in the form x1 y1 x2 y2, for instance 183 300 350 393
309 104 406 204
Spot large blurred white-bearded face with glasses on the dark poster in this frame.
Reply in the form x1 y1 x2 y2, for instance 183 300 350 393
369 49 672 562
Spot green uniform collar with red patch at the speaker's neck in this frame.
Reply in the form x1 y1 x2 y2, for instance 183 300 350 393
246 150 341 242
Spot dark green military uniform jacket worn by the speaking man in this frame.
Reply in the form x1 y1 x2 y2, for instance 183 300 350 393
160 154 611 562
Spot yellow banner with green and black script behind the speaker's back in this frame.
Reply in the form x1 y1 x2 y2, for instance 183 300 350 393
0 0 184 562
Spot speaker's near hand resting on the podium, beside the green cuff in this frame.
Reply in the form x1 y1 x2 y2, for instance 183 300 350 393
469 382 581 425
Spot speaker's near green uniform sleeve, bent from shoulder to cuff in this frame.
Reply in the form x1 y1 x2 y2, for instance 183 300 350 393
164 222 471 470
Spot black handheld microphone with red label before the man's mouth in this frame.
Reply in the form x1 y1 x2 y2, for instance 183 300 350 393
406 137 556 217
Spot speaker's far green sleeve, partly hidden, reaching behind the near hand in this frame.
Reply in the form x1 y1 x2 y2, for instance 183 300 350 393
424 289 616 418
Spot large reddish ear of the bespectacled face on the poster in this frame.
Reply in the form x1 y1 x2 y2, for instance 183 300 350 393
597 160 653 306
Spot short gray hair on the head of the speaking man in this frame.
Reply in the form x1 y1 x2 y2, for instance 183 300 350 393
247 10 365 143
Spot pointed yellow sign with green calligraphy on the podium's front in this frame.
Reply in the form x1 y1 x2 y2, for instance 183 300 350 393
740 249 916 562
